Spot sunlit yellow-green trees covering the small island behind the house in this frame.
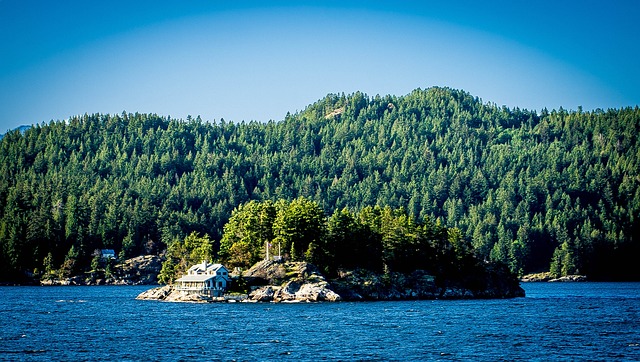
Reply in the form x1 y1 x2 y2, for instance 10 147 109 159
160 197 486 283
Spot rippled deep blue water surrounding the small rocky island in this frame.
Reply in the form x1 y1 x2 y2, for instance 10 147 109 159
0 283 640 361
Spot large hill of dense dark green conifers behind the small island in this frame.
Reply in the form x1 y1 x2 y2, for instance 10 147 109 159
0 88 640 280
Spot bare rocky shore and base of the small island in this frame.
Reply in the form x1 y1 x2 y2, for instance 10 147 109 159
136 260 524 303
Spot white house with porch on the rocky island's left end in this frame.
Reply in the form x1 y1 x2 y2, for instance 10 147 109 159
175 261 230 297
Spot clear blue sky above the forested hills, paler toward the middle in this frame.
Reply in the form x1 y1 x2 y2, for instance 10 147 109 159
0 0 640 133
